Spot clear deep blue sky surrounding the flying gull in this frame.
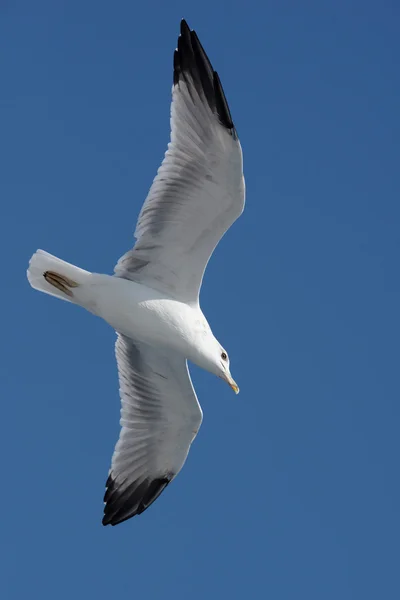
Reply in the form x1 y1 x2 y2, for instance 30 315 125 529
0 0 400 600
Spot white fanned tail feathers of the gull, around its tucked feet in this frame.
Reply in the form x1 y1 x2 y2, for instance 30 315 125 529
27 250 92 304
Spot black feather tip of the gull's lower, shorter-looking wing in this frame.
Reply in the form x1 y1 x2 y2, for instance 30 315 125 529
102 475 172 525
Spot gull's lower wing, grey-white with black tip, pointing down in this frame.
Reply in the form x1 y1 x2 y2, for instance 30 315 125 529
103 334 202 525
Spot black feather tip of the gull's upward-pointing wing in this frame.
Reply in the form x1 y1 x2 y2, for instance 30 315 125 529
174 19 237 138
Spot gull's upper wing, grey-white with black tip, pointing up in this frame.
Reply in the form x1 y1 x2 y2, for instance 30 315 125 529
115 21 245 303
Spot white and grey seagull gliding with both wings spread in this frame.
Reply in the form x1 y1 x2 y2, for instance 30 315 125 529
27 20 245 525
